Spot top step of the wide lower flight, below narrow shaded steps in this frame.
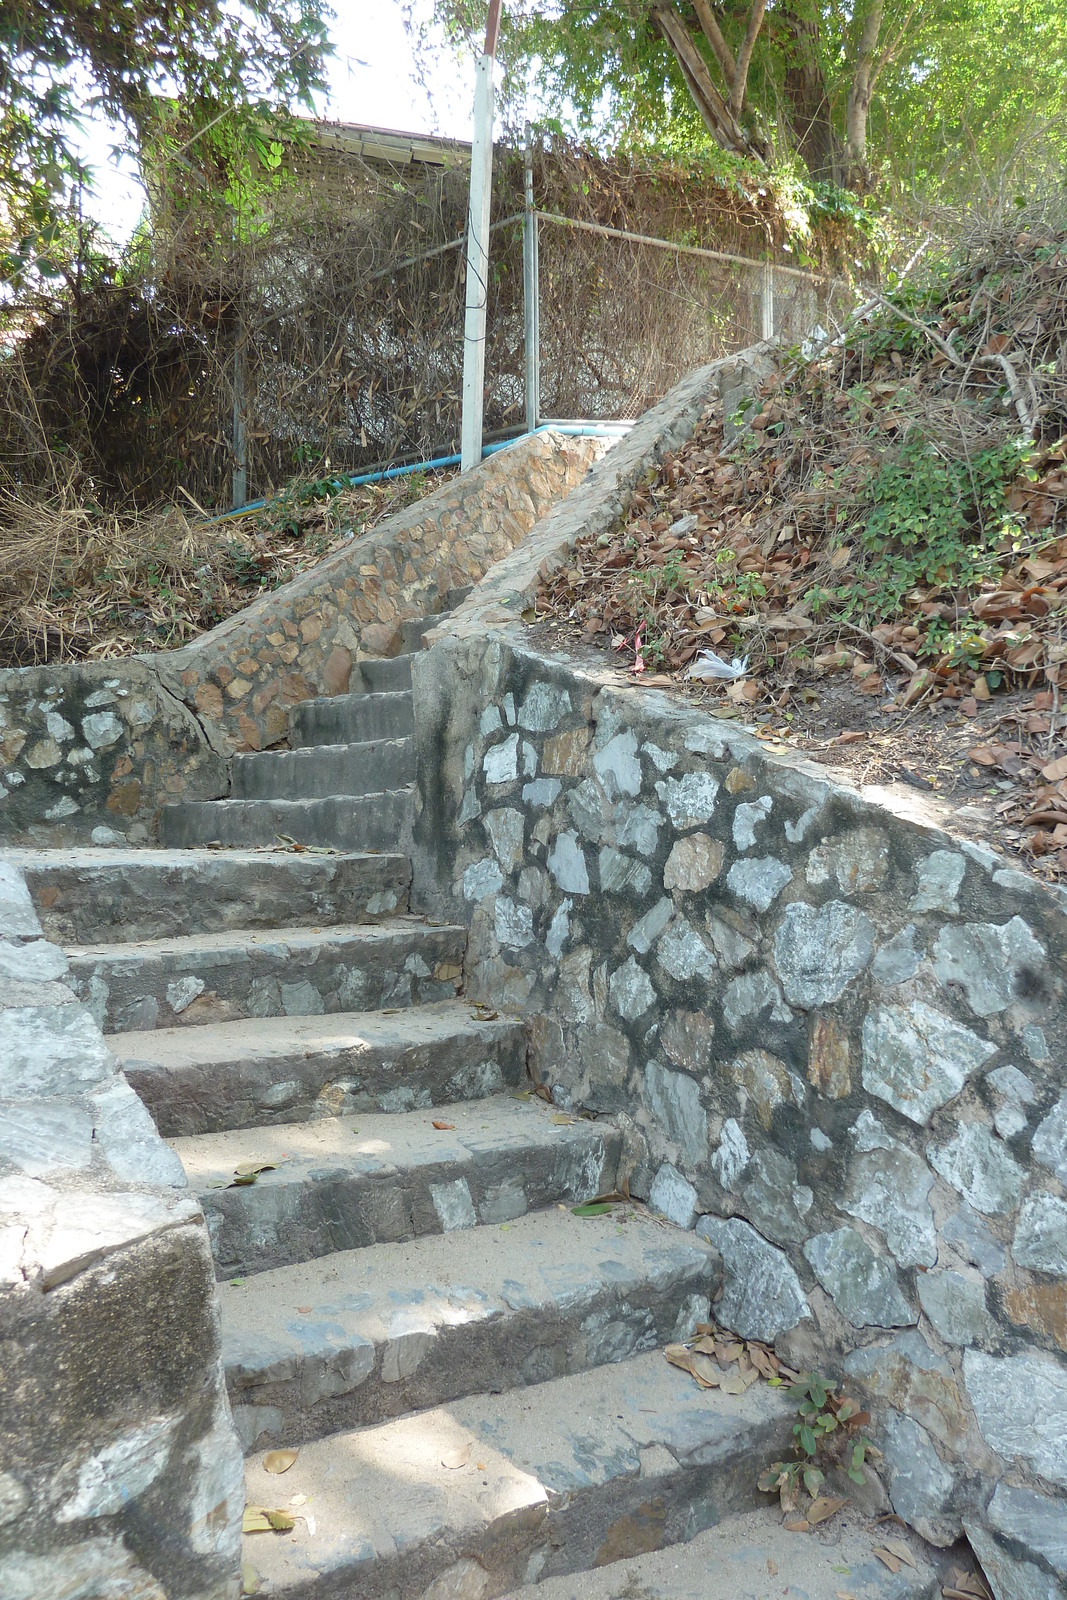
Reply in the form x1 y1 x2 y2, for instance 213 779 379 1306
3 848 411 944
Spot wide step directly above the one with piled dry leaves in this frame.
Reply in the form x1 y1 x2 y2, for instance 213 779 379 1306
219 1206 720 1450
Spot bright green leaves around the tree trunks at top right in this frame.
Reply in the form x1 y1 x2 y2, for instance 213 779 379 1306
434 0 1067 208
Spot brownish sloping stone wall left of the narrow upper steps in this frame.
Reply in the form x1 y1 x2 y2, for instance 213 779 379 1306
0 432 606 845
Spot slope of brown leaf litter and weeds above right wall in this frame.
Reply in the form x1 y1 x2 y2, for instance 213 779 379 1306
537 219 1067 880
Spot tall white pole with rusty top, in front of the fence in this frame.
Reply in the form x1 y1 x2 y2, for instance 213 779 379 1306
459 0 501 472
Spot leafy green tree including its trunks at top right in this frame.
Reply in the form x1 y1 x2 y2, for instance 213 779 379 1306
435 0 1067 202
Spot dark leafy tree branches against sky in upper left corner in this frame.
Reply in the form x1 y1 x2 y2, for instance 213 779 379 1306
0 0 330 275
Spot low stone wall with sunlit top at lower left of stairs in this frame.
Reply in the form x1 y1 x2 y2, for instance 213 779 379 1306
0 862 245 1600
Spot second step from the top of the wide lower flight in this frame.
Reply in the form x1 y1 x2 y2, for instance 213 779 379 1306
67 917 467 1034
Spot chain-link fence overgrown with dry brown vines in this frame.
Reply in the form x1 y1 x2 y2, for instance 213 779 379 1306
0 146 854 509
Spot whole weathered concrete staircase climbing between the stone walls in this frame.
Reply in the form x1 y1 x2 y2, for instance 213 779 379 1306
18 624 933 1600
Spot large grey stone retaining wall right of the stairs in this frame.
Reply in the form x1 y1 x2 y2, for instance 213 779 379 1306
414 360 1067 1600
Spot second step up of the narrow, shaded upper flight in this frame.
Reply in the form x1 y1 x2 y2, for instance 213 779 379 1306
230 739 414 800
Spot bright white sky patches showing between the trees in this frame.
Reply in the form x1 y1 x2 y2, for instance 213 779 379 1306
71 0 474 243
